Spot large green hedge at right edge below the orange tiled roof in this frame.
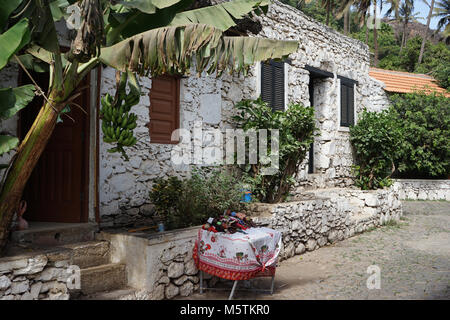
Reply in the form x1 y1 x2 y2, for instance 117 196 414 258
391 92 450 178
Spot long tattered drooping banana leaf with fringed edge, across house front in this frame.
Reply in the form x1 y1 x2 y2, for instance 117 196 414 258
99 24 299 75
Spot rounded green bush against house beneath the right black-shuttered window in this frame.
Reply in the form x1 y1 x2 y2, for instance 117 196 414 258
350 110 402 190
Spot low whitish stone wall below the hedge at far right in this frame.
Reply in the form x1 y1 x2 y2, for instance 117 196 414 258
393 179 450 201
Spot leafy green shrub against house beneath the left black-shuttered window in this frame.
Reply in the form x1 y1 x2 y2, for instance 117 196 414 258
234 98 316 203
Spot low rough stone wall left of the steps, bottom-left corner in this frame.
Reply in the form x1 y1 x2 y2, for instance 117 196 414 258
0 253 71 300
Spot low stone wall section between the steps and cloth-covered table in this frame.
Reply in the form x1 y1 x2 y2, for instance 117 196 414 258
98 226 202 300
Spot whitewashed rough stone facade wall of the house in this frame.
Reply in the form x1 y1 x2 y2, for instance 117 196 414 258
99 1 389 226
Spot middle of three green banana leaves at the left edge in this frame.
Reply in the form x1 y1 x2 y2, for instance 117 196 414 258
0 84 35 119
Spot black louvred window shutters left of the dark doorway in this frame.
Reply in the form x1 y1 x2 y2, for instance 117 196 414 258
261 60 285 111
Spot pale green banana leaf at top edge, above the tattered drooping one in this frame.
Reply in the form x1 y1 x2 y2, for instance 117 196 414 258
170 0 270 31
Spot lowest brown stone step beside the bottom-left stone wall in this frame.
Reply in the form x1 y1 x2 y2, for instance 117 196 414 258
80 263 127 295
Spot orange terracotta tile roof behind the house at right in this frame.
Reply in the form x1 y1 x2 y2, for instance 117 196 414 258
369 68 450 97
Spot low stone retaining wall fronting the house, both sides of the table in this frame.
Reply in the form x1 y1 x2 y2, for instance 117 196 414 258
103 188 402 300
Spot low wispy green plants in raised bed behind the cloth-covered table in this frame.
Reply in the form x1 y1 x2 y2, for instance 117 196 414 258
150 169 245 229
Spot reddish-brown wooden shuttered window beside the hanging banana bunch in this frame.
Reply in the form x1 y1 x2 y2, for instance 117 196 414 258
148 75 180 144
